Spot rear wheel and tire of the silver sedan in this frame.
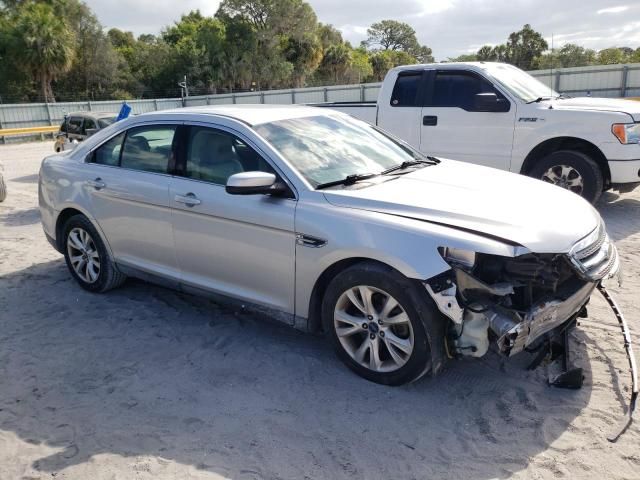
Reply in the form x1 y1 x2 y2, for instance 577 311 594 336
61 215 127 293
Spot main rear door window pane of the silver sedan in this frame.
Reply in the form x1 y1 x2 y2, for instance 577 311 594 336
120 125 176 173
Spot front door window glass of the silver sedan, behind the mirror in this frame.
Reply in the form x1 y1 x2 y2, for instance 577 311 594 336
184 126 275 185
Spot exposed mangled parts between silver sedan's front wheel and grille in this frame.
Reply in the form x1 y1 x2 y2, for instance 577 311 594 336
426 249 596 357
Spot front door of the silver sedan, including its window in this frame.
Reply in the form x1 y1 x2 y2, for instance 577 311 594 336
170 125 296 314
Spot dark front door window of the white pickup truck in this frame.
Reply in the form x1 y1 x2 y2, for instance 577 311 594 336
426 71 504 112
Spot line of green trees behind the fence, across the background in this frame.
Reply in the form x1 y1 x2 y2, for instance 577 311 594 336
0 0 640 103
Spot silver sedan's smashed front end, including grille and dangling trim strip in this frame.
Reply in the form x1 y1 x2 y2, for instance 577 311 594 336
424 226 638 441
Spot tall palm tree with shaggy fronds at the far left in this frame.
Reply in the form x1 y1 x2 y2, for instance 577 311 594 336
15 2 75 102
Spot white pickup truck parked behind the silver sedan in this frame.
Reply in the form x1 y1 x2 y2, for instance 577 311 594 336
317 62 640 203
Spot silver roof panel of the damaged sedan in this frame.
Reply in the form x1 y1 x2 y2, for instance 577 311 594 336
137 104 340 126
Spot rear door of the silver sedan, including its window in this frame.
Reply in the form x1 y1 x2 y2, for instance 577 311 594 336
85 124 179 282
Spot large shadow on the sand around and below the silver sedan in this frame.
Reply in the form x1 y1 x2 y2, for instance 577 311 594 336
0 260 591 479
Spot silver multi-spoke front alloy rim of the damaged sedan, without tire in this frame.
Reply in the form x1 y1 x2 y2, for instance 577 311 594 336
333 285 414 373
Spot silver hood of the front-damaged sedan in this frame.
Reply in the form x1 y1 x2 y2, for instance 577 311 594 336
323 160 601 253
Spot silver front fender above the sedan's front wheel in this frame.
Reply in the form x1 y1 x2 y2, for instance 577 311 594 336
295 202 523 318
